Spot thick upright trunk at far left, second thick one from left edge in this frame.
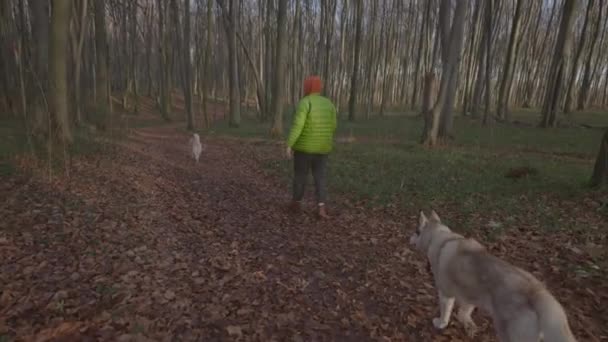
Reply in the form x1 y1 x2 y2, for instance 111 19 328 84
49 0 72 144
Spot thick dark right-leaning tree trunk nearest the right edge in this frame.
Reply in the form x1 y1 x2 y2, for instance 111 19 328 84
540 0 577 127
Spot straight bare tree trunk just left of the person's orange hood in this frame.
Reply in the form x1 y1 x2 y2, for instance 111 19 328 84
270 0 290 137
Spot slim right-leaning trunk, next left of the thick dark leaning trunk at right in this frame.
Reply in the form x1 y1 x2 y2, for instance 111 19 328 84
496 0 525 120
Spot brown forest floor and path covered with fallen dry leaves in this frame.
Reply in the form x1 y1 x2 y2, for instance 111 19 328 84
0 100 608 342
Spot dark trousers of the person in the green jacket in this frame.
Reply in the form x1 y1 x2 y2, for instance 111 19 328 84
293 151 327 203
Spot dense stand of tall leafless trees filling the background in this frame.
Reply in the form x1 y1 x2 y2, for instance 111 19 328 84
0 0 608 134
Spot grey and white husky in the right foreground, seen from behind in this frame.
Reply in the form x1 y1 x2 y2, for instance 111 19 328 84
410 211 576 342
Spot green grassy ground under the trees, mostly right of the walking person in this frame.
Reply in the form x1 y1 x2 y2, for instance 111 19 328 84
210 112 608 232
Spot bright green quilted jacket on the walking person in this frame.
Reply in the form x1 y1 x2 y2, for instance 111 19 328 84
287 94 337 154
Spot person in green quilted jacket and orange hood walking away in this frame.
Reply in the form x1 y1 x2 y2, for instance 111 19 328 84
286 76 337 219
